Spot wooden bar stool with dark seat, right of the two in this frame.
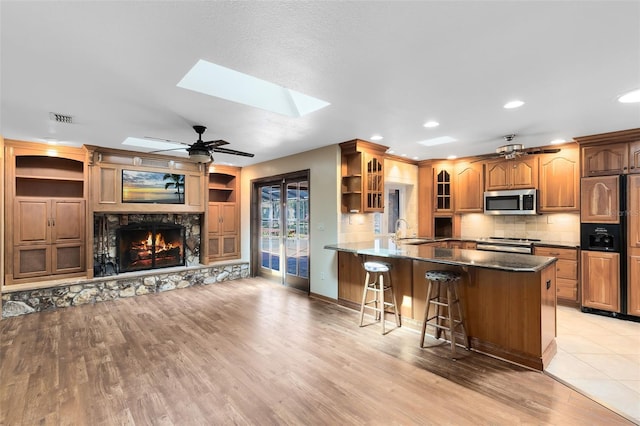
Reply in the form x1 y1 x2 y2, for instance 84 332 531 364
420 271 469 359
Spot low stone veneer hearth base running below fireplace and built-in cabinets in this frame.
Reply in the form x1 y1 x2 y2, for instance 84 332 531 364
2 262 249 318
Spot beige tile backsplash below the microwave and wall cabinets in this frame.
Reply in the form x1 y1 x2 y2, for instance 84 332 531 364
461 213 580 244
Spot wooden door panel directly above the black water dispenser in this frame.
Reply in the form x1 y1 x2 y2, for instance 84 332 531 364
580 176 620 223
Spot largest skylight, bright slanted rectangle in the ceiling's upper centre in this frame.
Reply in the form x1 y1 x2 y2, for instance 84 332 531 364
177 59 330 117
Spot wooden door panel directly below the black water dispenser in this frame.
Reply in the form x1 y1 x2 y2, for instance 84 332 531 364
581 251 620 312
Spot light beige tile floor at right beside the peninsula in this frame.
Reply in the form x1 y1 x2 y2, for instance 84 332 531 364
545 306 640 424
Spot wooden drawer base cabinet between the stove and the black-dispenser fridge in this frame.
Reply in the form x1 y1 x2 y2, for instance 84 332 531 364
533 246 580 306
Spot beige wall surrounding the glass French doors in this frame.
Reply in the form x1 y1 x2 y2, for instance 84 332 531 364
240 144 340 299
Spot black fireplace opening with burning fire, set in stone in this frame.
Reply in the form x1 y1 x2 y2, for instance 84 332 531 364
116 223 185 272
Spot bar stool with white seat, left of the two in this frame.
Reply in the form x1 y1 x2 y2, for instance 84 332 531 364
360 262 400 334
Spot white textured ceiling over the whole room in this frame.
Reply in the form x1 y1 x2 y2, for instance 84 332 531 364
0 0 640 166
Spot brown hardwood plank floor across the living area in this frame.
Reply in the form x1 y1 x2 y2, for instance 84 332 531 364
0 278 630 425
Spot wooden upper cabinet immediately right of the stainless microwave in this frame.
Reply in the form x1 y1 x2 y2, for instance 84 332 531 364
538 146 580 213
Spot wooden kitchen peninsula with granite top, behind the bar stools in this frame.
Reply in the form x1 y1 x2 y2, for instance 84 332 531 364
325 238 556 370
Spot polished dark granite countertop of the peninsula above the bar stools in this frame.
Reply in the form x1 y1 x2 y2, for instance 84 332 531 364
324 238 556 272
